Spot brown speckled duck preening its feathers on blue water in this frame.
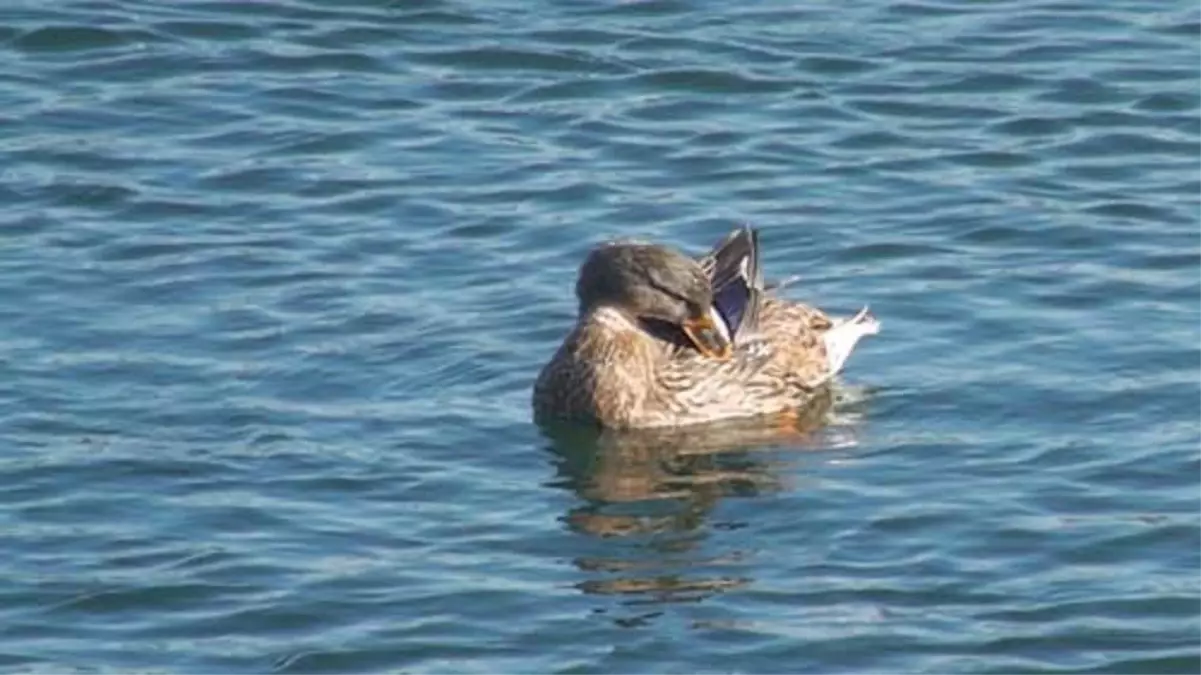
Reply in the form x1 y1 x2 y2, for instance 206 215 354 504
533 227 879 429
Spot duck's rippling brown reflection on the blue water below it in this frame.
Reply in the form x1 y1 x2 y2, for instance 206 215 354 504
543 394 859 626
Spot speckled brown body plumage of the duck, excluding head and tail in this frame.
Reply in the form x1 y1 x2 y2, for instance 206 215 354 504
533 225 879 429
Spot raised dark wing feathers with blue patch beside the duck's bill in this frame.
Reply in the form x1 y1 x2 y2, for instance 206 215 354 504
700 226 763 338
